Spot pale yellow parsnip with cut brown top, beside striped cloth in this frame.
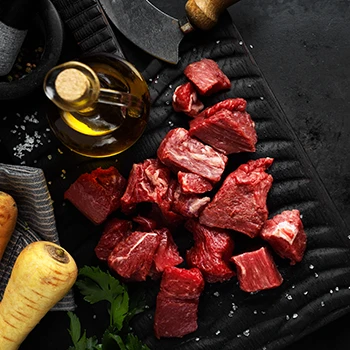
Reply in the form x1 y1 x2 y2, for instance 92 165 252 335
0 241 78 350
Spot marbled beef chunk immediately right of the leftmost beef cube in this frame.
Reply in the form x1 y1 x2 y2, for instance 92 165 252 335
121 159 170 214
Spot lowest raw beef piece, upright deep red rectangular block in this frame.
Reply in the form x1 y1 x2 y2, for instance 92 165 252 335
154 267 204 339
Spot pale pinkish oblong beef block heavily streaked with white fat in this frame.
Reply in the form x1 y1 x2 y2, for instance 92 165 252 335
157 128 227 182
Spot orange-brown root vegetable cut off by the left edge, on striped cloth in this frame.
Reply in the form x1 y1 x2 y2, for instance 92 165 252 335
0 191 18 261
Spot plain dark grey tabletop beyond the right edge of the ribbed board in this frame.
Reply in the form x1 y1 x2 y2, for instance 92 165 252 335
230 0 350 350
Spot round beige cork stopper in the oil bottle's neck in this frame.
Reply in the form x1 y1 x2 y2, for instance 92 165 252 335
55 68 90 102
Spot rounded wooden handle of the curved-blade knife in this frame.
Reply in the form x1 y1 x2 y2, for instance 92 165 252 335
185 0 239 30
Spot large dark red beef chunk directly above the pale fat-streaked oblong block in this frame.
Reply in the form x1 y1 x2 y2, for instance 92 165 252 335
189 109 257 154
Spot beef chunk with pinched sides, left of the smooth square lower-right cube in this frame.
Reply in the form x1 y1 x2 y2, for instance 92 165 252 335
185 220 235 283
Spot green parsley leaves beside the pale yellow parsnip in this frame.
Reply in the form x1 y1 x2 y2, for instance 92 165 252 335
68 266 149 350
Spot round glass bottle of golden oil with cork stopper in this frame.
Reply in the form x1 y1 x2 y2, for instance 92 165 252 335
44 53 150 157
